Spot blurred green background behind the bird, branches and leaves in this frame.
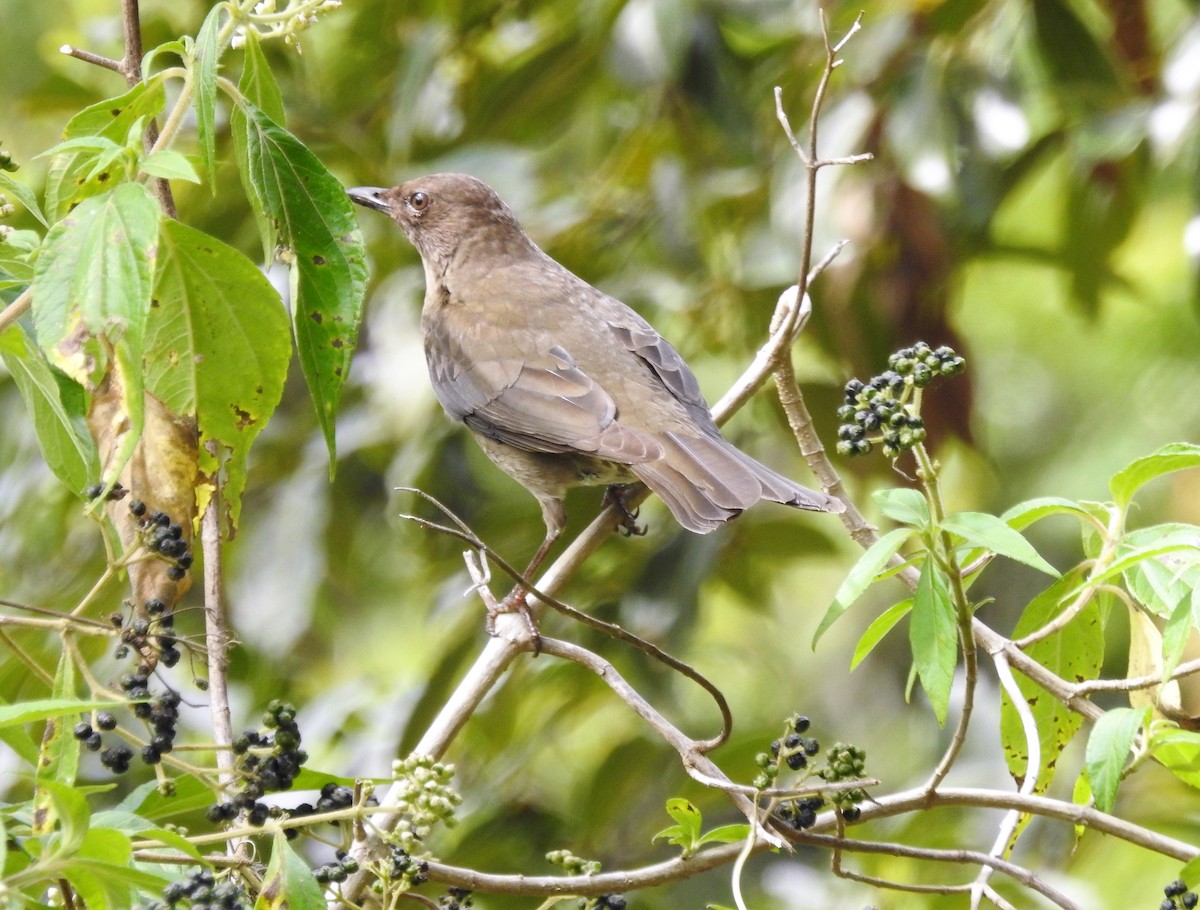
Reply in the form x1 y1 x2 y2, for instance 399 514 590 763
0 0 1200 909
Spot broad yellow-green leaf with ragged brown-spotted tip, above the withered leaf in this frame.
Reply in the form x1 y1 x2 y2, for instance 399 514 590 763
145 221 292 525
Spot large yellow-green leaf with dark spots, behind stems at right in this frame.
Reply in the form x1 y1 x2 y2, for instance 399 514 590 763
1000 570 1104 792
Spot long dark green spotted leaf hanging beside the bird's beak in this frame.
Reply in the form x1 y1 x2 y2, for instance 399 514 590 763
232 102 366 474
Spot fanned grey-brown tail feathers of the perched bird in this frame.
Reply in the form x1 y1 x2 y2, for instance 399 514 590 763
629 432 845 534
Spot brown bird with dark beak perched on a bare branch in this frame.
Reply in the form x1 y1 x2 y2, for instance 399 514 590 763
349 174 844 595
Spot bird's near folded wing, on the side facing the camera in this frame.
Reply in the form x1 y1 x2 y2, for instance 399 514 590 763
425 327 662 465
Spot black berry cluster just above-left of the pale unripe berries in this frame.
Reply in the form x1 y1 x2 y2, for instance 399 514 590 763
208 699 304 826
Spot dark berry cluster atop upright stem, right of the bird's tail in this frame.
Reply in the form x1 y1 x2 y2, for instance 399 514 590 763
838 341 966 459
